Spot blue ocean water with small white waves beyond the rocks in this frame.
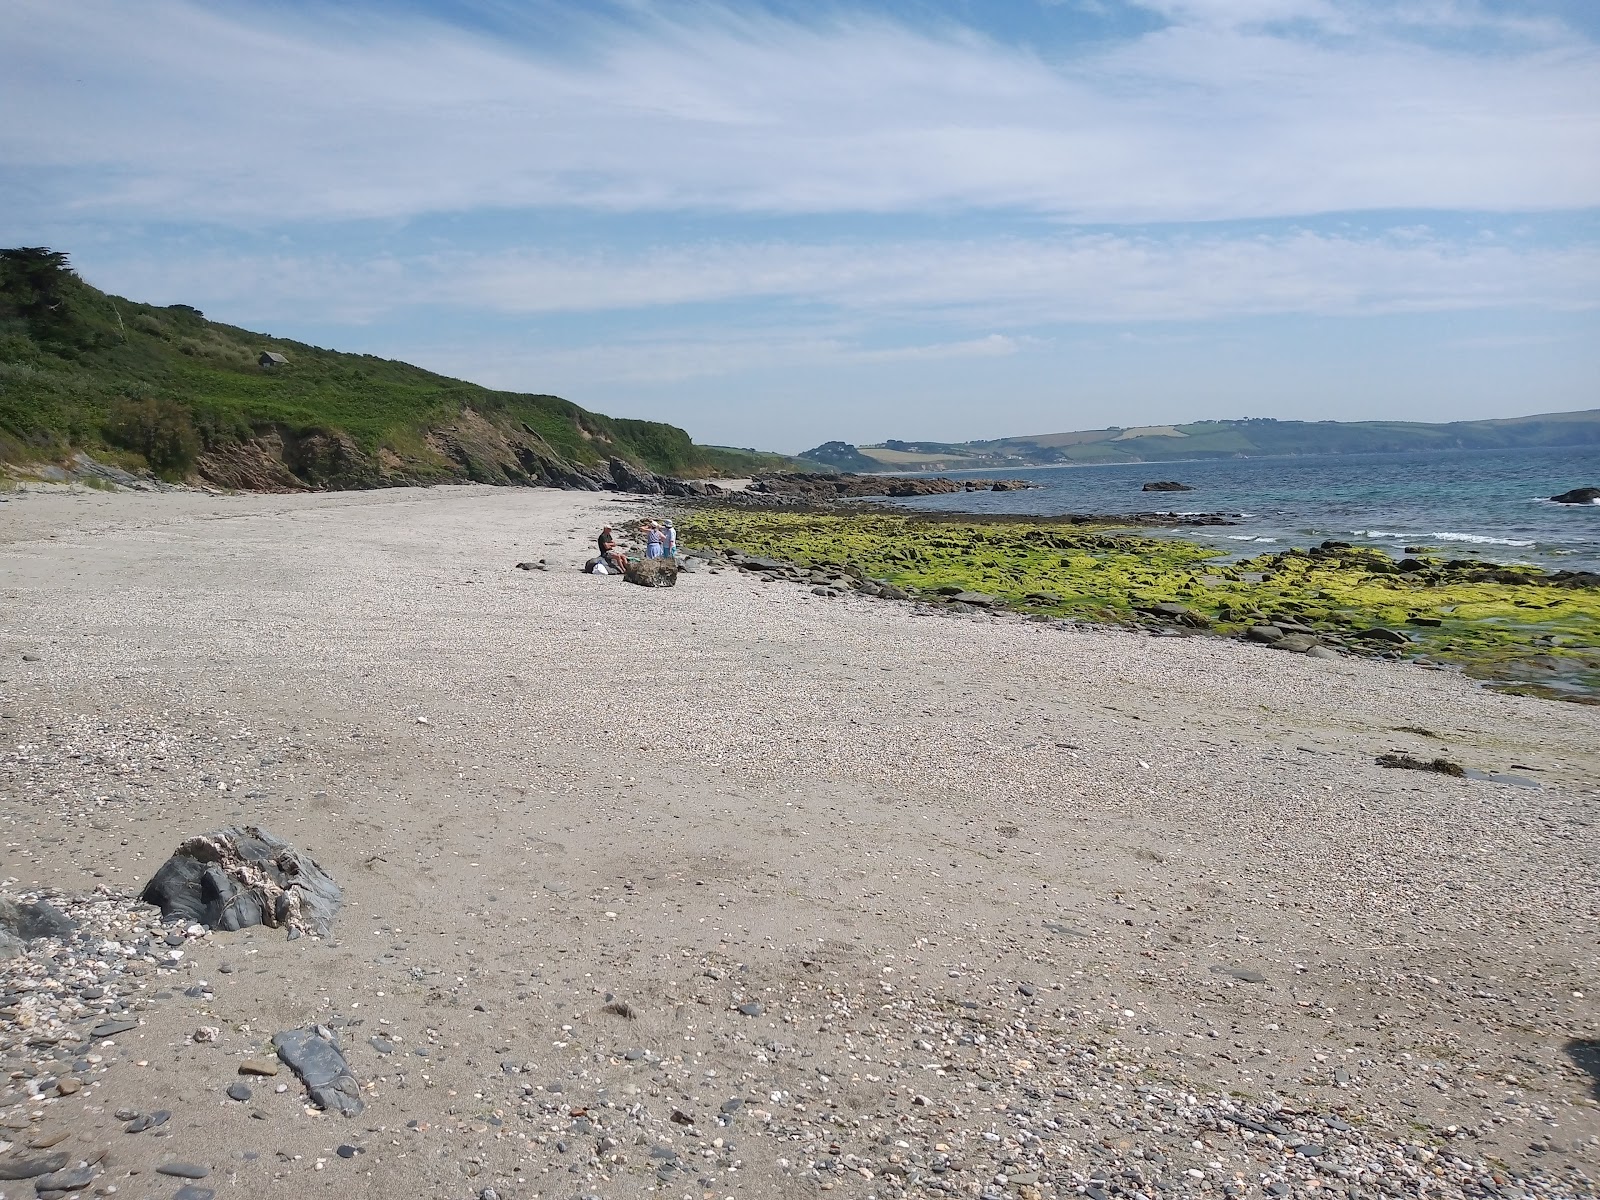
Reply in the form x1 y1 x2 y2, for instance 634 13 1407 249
896 446 1600 571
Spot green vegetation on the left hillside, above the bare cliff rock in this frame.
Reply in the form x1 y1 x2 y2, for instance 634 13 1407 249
0 251 796 475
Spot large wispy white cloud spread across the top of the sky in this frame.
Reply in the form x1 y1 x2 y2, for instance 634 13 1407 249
0 0 1600 226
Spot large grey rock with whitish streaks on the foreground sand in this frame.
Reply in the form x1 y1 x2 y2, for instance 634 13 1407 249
139 826 341 936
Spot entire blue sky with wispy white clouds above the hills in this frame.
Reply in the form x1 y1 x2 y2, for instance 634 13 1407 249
0 0 1600 453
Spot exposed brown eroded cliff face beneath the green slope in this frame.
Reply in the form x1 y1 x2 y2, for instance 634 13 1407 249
195 408 704 496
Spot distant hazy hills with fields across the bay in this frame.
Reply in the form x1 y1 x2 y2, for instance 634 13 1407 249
806 410 1600 470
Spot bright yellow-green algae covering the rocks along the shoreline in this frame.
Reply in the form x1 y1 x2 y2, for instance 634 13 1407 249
678 506 1600 702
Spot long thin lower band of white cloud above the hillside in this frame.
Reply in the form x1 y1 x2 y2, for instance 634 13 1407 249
78 226 1600 336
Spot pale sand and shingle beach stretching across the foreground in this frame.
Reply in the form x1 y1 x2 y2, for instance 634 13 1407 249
0 488 1600 1198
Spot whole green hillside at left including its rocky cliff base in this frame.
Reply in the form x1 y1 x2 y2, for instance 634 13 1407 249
0 248 794 488
